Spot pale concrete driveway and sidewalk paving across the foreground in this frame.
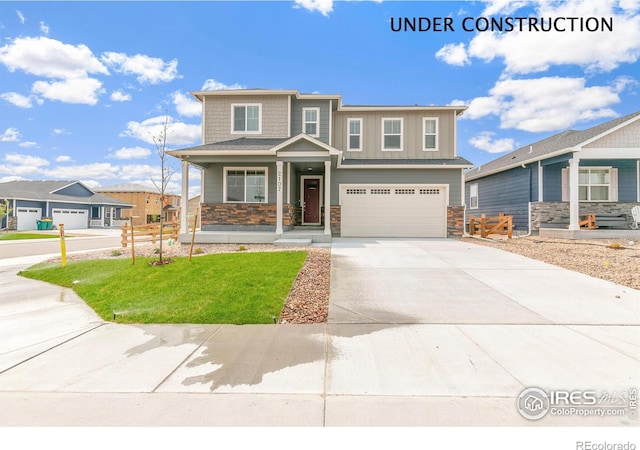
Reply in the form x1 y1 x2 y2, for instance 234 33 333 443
0 239 640 426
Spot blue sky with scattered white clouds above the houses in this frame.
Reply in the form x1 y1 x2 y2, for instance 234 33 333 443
0 0 640 195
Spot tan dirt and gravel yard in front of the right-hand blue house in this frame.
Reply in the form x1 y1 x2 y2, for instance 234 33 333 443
465 236 640 289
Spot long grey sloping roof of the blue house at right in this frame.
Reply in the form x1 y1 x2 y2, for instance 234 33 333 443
465 111 640 180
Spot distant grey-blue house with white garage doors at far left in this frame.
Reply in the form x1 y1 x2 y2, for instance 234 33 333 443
0 180 131 230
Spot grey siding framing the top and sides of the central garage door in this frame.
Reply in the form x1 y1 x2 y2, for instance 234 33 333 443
331 164 462 206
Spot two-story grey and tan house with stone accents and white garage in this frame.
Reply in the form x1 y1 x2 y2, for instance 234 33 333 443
169 89 472 240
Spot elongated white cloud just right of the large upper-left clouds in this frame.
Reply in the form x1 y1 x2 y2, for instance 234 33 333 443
102 52 179 84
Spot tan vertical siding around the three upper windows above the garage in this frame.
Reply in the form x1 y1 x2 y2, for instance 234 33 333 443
333 110 456 159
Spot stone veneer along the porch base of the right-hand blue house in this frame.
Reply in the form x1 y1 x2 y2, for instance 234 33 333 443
531 202 640 232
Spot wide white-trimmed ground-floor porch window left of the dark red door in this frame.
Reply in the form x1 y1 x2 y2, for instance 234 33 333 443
224 167 267 203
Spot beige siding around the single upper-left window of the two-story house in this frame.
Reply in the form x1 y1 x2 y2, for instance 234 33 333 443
202 95 290 144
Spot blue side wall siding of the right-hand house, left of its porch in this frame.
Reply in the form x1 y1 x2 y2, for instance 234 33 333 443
465 163 538 231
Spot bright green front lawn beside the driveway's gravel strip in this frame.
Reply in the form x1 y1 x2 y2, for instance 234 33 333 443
20 251 307 324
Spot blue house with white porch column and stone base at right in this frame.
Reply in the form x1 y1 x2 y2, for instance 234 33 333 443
465 111 640 237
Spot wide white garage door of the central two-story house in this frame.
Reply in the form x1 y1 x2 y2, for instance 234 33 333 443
340 185 447 237
